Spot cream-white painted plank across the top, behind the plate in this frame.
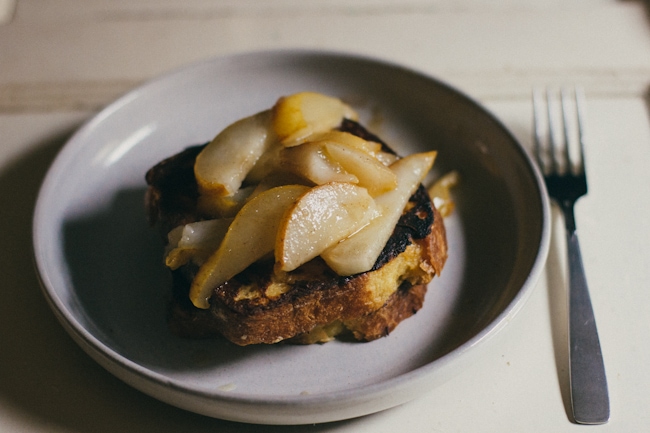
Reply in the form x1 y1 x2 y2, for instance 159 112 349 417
0 0 650 111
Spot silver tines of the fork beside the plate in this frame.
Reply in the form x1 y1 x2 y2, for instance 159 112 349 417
533 87 584 175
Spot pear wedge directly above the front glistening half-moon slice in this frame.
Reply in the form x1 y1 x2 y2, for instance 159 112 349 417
322 142 397 197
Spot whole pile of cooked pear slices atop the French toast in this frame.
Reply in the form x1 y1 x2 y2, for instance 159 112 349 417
166 92 436 309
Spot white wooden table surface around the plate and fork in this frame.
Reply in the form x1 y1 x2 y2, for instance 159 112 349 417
0 0 650 433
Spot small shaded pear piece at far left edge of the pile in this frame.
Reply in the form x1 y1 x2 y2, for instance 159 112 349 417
165 218 232 269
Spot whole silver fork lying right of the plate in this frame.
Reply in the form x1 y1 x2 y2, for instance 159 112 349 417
533 89 609 424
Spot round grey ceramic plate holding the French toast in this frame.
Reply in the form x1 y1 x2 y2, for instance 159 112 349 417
34 52 549 424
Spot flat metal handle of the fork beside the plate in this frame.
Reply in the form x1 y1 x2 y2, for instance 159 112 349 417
565 216 609 424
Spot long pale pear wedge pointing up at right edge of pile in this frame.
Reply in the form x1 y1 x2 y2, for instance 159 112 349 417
321 151 436 275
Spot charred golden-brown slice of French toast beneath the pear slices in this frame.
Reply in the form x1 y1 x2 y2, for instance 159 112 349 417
146 119 447 345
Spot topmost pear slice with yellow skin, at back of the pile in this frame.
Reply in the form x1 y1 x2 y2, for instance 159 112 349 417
273 92 358 146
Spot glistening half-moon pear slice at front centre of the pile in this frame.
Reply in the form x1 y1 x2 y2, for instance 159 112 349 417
275 182 378 272
